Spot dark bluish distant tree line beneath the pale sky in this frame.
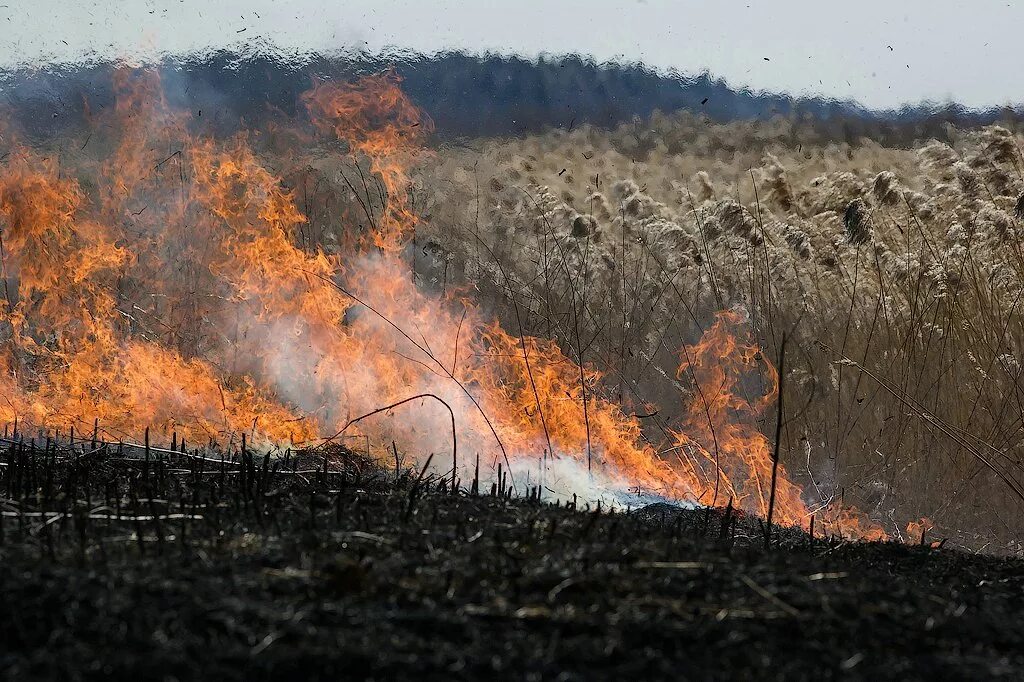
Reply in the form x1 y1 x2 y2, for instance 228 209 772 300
0 51 1021 145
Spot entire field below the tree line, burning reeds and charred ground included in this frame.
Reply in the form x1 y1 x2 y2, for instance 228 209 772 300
0 69 1024 679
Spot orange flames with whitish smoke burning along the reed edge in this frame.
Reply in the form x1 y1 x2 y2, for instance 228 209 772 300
0 71 882 537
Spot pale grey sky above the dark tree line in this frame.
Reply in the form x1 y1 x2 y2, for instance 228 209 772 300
0 0 1024 108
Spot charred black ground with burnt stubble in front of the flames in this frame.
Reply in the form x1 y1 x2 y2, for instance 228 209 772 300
0 441 1024 680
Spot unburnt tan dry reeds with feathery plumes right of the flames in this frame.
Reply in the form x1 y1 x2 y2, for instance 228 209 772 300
403 110 1024 552
